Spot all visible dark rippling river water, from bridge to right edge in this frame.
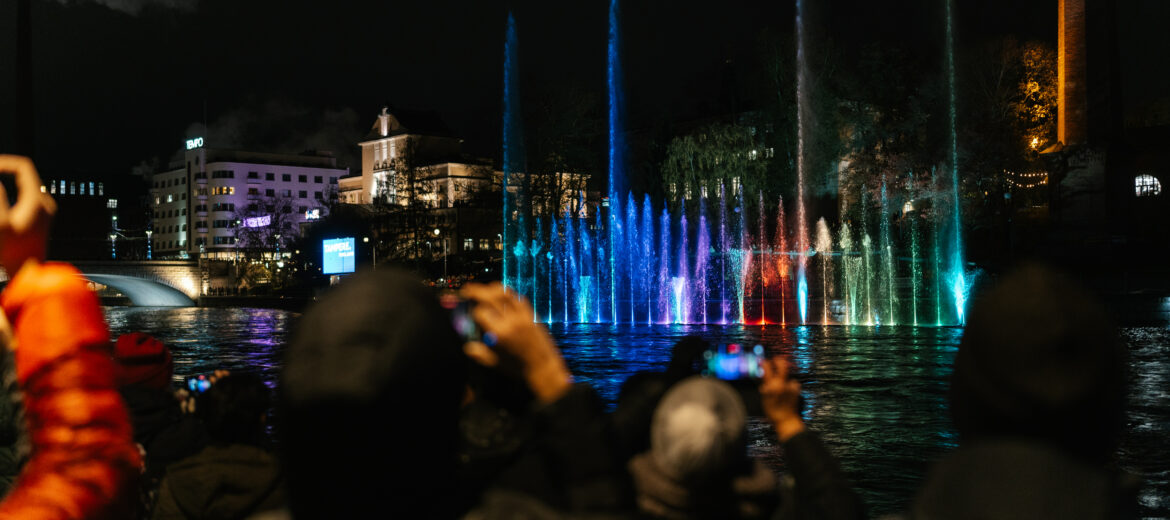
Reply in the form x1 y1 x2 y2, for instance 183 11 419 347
105 307 1170 518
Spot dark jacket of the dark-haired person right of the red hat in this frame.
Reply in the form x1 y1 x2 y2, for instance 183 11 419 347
151 444 285 520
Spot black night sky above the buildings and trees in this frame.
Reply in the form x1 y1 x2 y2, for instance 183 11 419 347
0 0 1170 178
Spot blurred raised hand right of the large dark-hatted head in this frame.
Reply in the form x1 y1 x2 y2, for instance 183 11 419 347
460 283 572 403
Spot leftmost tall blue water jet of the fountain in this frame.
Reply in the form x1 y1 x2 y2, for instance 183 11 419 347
501 13 523 292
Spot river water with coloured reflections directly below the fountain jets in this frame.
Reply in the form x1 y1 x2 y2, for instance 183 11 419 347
551 324 962 513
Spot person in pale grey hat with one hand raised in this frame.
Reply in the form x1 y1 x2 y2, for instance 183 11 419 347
629 358 865 519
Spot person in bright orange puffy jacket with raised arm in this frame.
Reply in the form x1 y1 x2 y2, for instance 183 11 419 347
0 155 142 520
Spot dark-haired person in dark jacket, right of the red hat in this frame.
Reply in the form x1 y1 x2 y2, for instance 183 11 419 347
151 374 285 520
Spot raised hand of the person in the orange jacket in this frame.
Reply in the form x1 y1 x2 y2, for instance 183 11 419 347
0 155 57 278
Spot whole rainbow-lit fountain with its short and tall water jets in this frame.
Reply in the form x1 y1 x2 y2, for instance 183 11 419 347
502 0 970 326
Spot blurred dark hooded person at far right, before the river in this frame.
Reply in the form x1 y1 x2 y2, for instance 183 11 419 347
911 265 1136 519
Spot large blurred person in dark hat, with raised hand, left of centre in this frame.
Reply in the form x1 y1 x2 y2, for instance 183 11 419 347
277 271 625 519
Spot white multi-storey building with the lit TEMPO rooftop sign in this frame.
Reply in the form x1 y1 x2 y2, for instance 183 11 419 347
150 143 349 259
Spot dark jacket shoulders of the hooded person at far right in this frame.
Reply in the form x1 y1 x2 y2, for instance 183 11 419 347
910 438 1137 519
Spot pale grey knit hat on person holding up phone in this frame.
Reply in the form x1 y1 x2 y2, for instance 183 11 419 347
651 376 748 483
